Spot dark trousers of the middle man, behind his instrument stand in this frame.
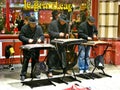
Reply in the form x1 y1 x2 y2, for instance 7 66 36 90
47 46 67 71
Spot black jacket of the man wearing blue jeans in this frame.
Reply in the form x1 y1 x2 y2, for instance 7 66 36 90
78 21 98 40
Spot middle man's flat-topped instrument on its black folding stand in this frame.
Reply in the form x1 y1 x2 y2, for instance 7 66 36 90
51 39 86 84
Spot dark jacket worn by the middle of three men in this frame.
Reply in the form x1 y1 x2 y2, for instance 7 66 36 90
48 20 68 40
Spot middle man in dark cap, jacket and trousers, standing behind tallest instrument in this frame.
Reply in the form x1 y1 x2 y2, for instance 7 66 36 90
47 14 69 77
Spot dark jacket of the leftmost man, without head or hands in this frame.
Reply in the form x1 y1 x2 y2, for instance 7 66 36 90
18 24 44 45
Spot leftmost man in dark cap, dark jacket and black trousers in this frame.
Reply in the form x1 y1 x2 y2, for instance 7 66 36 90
18 17 44 81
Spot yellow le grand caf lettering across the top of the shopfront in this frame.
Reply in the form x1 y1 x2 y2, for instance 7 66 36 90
24 0 72 12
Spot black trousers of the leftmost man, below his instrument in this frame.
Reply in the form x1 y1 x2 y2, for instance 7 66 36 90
20 49 39 76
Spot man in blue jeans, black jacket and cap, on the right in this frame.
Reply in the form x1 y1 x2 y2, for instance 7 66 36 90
78 16 98 73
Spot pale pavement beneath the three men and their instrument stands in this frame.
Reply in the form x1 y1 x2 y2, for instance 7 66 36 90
0 62 120 90
